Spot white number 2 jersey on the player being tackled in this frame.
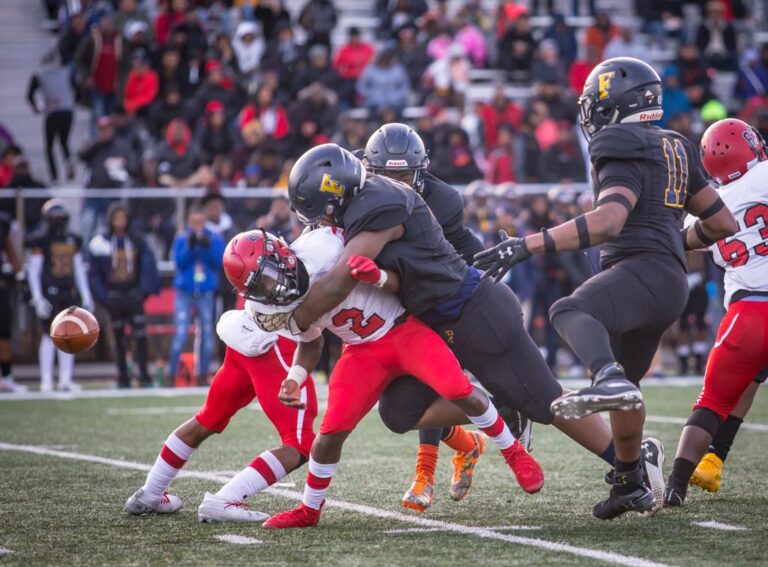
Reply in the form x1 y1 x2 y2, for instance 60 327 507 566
245 227 405 345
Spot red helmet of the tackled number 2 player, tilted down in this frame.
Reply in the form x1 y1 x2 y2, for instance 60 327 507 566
223 229 306 305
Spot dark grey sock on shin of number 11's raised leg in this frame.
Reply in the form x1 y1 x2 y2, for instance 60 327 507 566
552 310 615 376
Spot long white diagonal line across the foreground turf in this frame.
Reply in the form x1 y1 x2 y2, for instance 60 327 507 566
0 442 667 567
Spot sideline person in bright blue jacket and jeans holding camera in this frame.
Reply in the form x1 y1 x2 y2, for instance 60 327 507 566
168 207 224 385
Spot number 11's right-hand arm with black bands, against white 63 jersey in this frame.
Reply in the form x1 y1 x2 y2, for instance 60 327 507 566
682 185 739 250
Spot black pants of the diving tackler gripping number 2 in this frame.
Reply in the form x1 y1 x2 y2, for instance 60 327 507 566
379 280 562 433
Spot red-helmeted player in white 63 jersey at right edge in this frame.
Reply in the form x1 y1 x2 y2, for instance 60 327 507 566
664 118 768 506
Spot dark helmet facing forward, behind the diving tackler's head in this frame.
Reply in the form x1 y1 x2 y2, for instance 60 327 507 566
363 122 429 193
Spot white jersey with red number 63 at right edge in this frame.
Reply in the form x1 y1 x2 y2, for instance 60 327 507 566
686 161 768 308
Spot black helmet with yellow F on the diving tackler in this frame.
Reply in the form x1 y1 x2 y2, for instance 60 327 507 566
288 144 365 225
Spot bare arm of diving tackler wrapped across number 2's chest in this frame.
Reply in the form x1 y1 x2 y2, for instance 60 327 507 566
292 225 404 330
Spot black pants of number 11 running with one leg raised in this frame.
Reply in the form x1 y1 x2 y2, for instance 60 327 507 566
550 254 688 384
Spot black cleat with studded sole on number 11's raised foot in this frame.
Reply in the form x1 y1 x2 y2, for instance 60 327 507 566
550 362 643 419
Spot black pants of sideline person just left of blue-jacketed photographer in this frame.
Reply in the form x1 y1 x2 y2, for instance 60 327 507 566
107 294 152 388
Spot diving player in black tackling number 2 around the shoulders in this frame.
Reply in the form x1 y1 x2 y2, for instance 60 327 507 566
257 144 636 510
